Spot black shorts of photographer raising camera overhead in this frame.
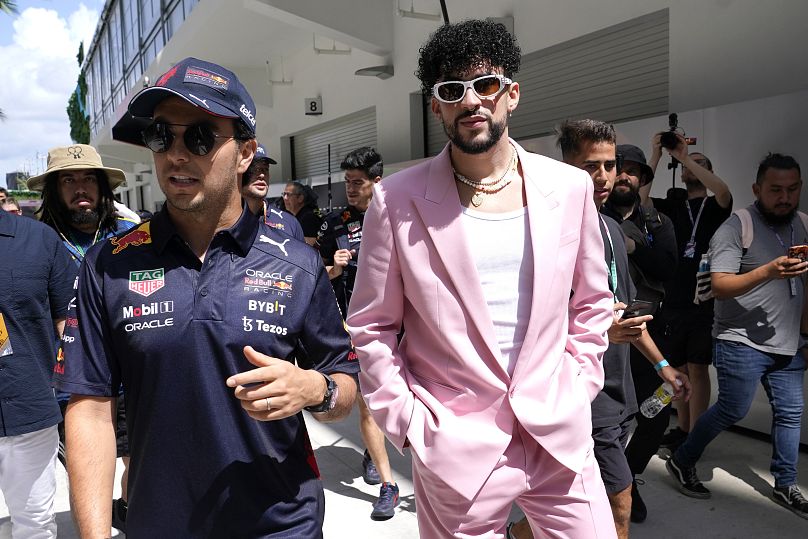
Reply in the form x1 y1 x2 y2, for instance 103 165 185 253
652 308 713 367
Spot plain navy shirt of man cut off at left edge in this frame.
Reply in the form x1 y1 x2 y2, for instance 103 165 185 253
0 211 77 438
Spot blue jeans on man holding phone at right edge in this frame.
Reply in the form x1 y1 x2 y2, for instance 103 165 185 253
675 339 805 487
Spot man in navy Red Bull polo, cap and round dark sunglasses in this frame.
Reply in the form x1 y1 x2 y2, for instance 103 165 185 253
57 58 359 538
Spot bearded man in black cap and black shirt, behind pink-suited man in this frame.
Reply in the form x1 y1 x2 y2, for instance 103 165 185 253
601 144 678 522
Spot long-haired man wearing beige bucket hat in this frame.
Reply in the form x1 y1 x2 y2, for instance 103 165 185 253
28 144 136 530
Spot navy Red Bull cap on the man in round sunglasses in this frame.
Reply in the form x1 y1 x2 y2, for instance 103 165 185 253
129 58 255 135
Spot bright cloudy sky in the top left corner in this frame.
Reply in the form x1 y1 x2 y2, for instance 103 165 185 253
0 0 104 186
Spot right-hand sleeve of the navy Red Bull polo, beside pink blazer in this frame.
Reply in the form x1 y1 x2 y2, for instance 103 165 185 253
300 264 359 374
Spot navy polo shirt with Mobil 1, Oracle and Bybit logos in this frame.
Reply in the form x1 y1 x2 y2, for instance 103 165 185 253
57 206 359 538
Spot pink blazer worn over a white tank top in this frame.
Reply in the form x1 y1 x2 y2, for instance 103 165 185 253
348 141 613 499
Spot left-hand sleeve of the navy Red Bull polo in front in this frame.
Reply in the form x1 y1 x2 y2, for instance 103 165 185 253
56 250 120 397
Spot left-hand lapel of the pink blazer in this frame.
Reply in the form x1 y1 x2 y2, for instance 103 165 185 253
413 145 508 379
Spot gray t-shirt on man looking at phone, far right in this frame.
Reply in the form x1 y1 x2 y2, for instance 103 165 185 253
710 205 808 356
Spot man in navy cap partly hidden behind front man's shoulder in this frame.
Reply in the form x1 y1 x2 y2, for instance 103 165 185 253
241 144 304 241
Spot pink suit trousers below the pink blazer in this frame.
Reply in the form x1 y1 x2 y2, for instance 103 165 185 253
412 427 617 539
